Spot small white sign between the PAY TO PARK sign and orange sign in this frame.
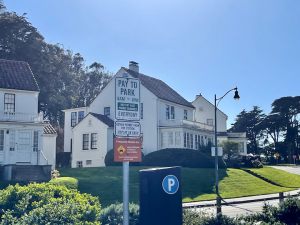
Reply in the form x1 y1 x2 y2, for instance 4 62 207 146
115 121 141 137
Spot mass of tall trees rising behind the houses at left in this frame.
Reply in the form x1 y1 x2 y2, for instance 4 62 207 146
0 2 110 126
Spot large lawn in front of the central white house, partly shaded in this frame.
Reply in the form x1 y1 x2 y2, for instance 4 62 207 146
60 167 291 206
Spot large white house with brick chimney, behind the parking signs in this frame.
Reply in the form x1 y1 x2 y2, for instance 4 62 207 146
64 62 246 167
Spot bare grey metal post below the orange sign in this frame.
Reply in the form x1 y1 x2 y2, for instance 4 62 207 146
123 162 129 225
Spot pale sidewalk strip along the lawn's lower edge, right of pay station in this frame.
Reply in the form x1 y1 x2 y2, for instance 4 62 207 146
182 189 300 208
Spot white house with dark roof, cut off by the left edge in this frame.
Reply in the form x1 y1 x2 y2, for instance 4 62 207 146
0 59 56 180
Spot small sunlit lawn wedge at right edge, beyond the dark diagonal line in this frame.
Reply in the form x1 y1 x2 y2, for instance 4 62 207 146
251 167 300 188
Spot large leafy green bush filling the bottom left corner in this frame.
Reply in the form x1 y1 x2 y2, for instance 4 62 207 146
0 183 101 225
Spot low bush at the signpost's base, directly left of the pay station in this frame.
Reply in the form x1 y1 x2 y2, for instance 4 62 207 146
100 203 139 225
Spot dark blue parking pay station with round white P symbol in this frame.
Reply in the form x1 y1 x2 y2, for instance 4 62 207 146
140 167 182 225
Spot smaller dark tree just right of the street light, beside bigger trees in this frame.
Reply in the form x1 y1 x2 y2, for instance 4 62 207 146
230 106 265 154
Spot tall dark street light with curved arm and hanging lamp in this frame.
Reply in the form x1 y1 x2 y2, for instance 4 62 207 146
215 87 240 215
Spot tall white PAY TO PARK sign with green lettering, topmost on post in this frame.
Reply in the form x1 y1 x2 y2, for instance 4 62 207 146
116 77 140 120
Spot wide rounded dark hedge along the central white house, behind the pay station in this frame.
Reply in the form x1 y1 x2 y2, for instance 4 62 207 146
142 148 225 168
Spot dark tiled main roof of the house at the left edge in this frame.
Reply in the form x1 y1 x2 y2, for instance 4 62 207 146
0 59 39 91
